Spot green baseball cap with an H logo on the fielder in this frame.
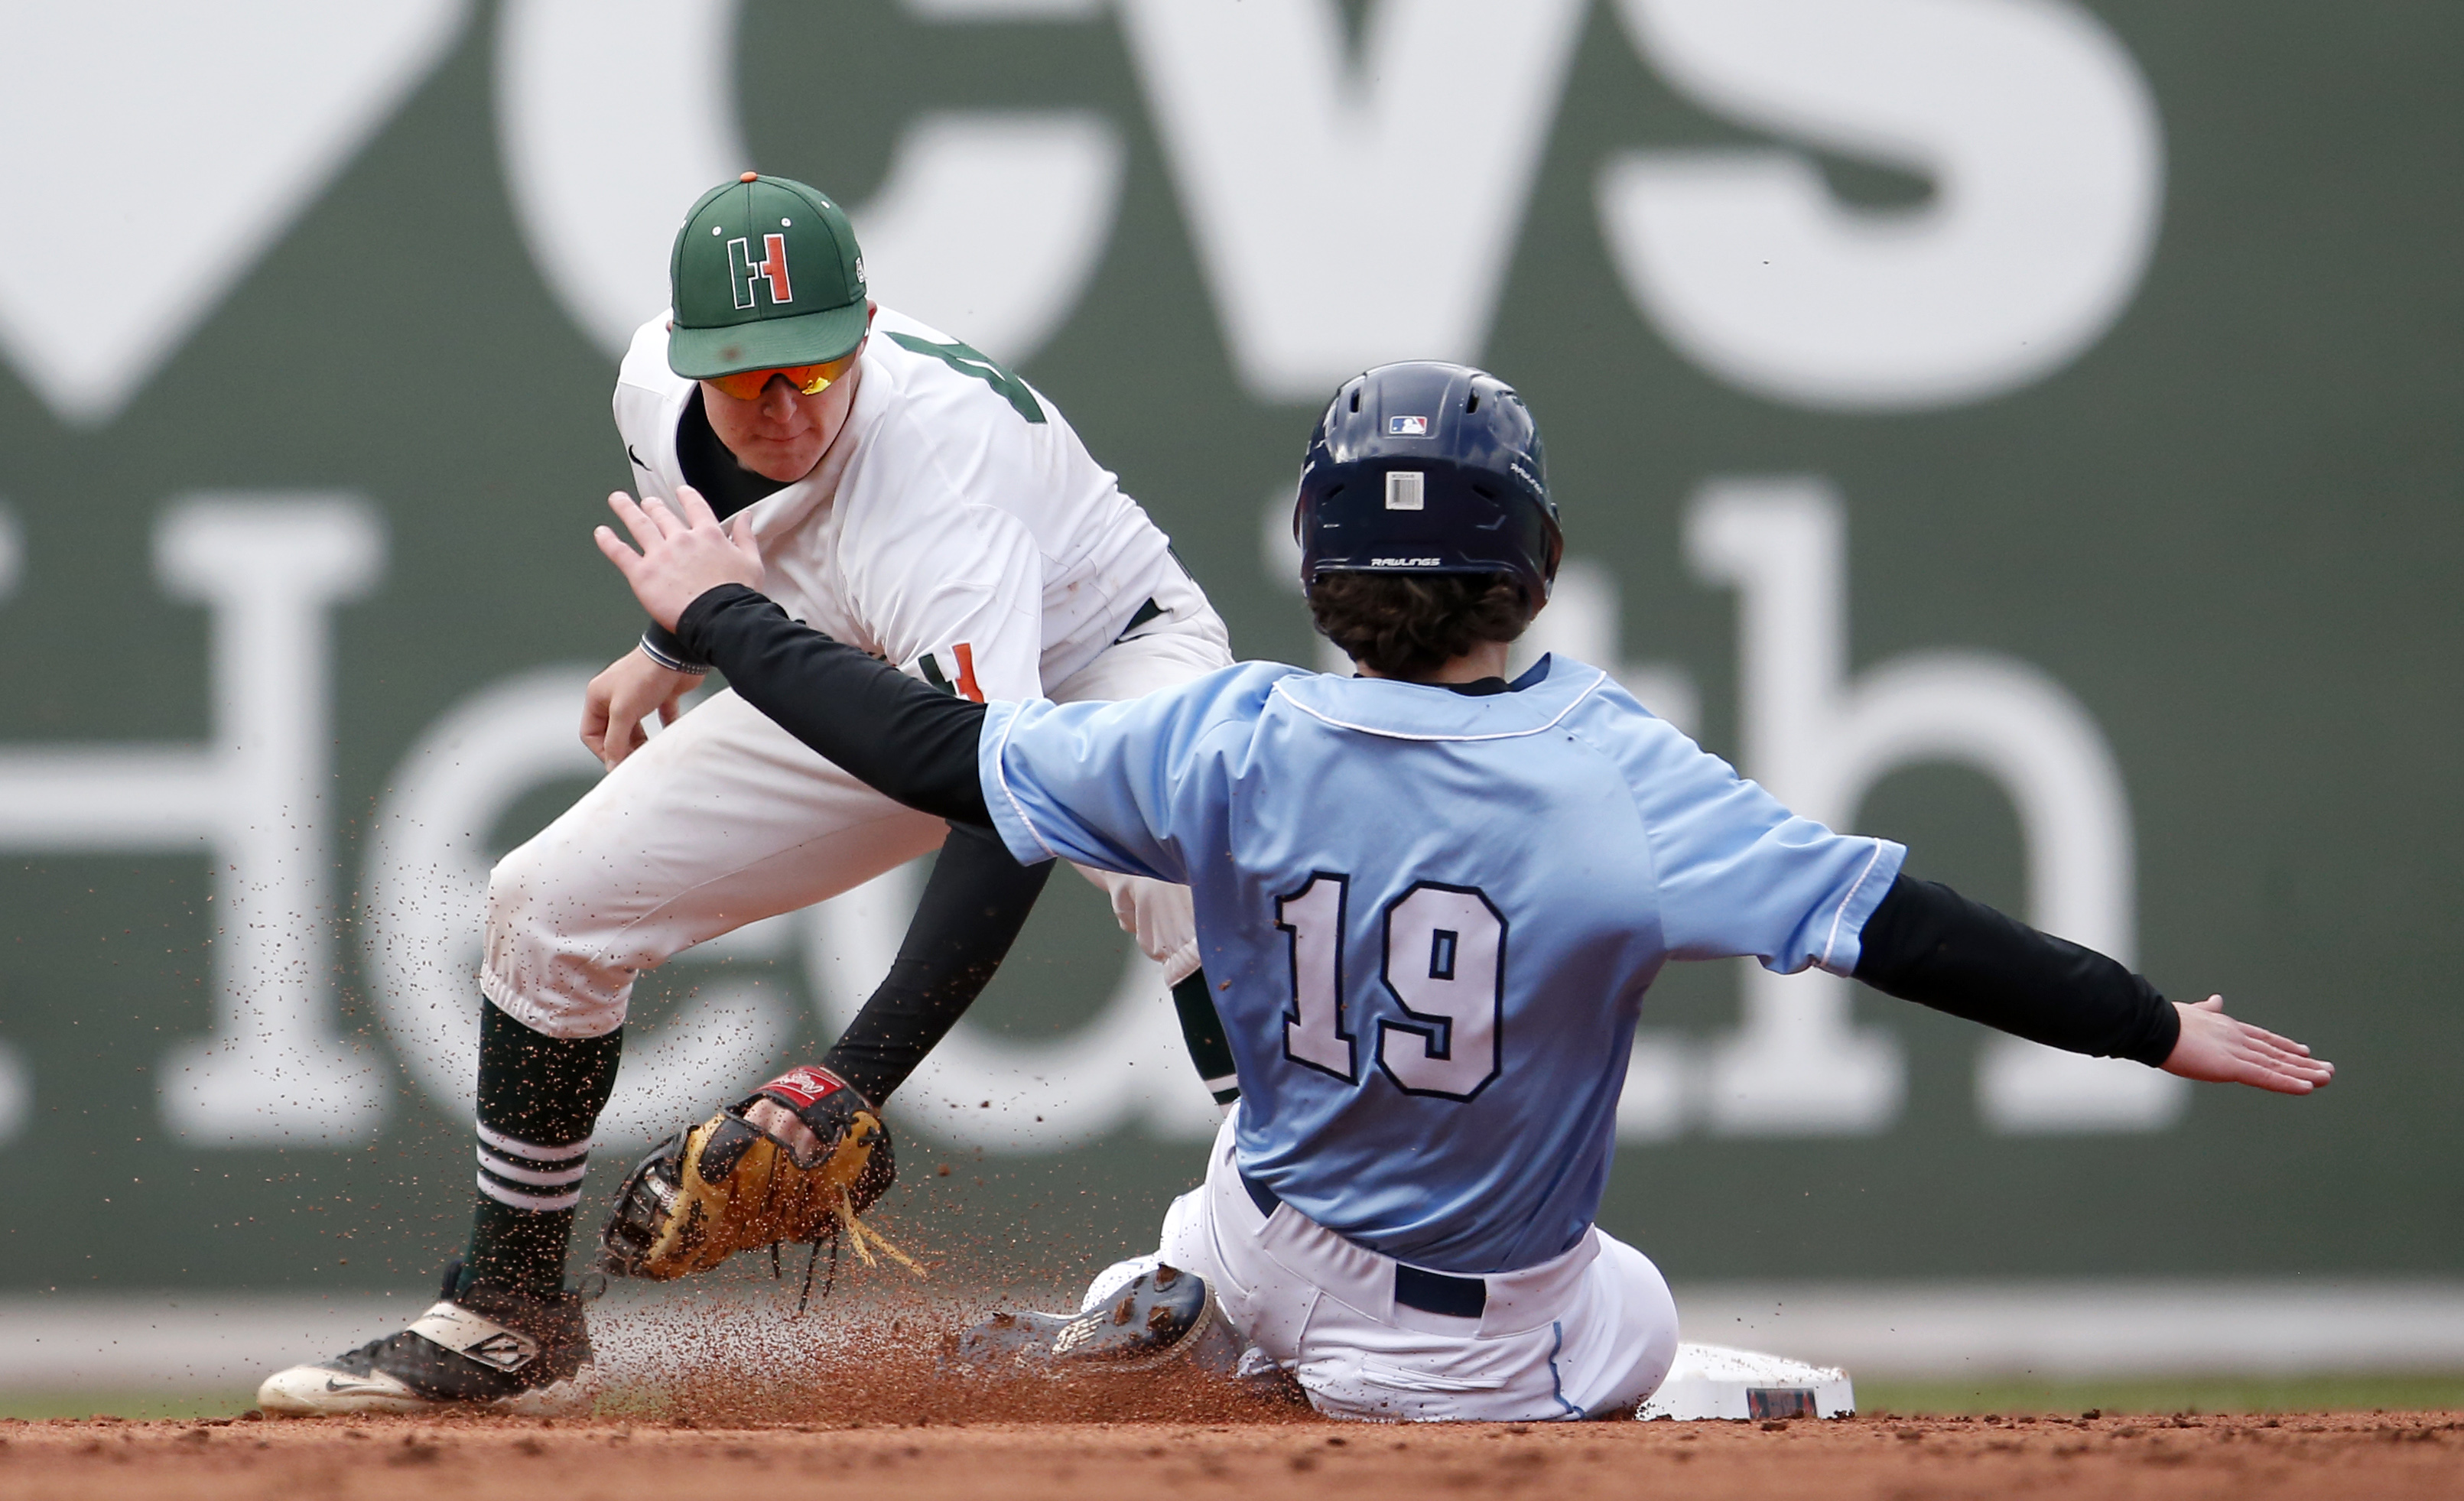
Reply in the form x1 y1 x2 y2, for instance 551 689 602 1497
668 173 865 379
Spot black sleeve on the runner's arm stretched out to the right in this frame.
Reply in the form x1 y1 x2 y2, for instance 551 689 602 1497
1855 875 2180 1067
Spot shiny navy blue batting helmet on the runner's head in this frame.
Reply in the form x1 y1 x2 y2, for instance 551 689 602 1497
1291 360 1565 609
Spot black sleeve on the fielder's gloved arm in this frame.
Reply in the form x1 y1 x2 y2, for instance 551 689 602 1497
821 824 1052 1104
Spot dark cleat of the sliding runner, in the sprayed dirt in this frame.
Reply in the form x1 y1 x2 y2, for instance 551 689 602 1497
956 1267 1242 1376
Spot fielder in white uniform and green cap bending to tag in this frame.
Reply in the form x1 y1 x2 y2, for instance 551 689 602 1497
258 173 1232 1415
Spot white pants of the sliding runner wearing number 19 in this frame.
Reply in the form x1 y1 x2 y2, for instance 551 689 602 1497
1138 1112 1678 1422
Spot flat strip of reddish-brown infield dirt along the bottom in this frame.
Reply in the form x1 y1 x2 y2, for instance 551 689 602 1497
0 1412 2464 1501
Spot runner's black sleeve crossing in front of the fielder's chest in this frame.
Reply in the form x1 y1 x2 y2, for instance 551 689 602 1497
675 584 993 826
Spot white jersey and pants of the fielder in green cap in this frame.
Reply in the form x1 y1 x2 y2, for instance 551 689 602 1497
549 263 1232 1030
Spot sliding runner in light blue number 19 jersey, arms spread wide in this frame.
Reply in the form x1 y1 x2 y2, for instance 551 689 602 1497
599 365 2333 1420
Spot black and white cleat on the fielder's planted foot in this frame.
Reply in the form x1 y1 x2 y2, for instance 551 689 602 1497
256 1259 596 1417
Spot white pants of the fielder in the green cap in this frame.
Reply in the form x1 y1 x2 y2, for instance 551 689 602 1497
480 591 1232 1038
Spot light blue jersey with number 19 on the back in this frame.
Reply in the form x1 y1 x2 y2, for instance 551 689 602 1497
980 661 1905 1274
